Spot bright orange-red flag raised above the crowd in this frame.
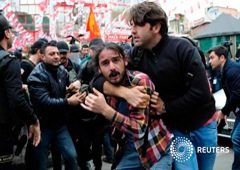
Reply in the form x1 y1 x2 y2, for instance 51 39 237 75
86 5 101 40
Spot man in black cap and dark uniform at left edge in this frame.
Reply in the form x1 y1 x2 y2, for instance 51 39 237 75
0 14 41 170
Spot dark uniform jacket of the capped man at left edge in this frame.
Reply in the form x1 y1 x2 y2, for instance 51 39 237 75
0 46 37 125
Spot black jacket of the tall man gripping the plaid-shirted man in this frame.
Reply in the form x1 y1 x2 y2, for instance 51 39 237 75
93 34 215 132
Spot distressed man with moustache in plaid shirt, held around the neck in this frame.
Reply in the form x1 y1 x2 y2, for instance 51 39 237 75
81 43 173 170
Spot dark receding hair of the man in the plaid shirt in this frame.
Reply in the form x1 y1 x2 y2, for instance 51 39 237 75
94 42 125 67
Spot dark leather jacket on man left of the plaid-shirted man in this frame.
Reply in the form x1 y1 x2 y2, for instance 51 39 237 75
27 62 68 128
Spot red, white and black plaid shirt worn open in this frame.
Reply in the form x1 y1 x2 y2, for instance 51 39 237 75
107 70 173 168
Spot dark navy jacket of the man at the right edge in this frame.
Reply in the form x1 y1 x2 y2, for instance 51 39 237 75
221 59 240 115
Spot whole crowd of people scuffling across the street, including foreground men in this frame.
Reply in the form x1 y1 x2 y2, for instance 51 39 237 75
0 1 240 170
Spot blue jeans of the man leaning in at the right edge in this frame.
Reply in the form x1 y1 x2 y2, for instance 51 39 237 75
232 112 240 170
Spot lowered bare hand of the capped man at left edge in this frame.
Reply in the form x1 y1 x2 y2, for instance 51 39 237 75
28 120 41 147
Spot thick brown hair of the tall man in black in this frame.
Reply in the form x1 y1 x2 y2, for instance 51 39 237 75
127 1 168 35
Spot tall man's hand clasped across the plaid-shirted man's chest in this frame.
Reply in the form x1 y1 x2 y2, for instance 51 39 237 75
124 86 150 109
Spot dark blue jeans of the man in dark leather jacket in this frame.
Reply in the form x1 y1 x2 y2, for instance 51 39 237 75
34 125 78 170
